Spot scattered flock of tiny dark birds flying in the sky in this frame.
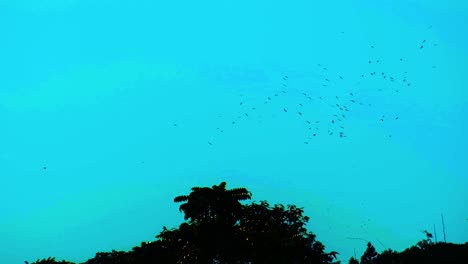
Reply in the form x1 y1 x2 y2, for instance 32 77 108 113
174 35 436 146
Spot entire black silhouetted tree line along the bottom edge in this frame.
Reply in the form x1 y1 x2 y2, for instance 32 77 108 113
26 182 468 264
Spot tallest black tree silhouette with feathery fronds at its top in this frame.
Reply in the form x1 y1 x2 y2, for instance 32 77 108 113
170 182 251 263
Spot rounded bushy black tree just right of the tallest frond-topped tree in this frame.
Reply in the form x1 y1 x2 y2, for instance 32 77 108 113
239 201 336 263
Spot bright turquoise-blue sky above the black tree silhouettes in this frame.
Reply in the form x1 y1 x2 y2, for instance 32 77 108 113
0 0 468 263
